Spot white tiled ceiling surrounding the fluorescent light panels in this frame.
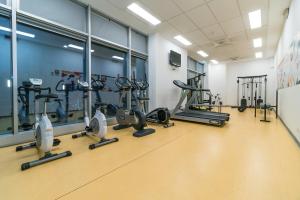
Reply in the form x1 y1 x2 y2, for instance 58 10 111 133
80 0 291 61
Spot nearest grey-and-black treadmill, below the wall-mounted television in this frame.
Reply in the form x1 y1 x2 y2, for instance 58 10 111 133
171 80 229 126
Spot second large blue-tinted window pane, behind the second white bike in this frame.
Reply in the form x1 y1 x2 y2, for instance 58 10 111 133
92 44 127 117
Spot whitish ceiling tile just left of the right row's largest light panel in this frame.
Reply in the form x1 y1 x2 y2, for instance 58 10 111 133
221 17 245 36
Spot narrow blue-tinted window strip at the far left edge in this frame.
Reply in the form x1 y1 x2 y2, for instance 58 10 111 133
0 16 12 134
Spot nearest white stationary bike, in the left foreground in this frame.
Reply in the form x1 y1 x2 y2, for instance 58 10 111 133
16 78 72 171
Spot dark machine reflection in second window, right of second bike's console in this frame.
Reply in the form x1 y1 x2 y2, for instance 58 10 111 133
92 75 118 116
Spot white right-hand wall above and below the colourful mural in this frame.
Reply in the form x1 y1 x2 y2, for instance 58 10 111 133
275 0 300 142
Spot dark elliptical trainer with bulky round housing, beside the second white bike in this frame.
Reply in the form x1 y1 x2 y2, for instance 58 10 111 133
113 75 155 137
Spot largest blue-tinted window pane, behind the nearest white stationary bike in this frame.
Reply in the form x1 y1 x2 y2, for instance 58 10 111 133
17 24 85 130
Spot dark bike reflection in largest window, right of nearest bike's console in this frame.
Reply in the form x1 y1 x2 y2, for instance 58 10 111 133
51 74 76 123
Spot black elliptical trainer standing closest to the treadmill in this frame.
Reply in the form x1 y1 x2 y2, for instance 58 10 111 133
132 73 174 128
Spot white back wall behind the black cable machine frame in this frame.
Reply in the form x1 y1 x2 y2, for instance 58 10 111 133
208 58 276 106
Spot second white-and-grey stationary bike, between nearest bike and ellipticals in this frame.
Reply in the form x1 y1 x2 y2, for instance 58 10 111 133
72 81 119 150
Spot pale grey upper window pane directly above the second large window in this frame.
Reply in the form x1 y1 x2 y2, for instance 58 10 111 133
91 13 128 46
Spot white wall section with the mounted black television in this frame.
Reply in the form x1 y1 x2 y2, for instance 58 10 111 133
148 34 187 110
